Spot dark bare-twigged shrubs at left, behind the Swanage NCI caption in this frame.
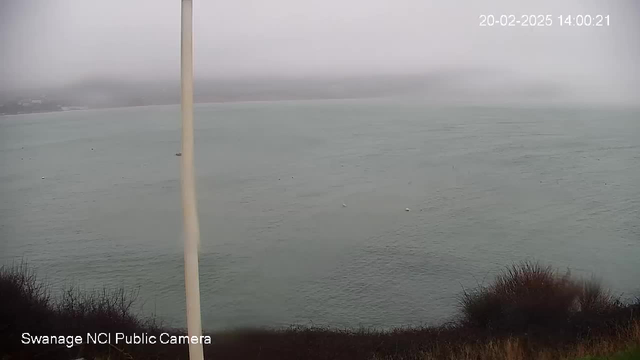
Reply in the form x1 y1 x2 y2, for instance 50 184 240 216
0 263 165 359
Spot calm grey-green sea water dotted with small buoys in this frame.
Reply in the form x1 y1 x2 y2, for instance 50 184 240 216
0 101 640 330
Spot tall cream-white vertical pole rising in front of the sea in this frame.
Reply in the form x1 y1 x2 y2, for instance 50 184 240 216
180 0 204 360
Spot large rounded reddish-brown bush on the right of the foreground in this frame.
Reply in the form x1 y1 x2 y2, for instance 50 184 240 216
461 262 622 334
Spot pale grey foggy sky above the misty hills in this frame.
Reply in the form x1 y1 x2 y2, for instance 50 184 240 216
0 0 640 99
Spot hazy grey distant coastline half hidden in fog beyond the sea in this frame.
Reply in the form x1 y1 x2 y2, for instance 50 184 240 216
5 70 637 115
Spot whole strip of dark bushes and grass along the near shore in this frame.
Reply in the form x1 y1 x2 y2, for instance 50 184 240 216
0 263 640 360
